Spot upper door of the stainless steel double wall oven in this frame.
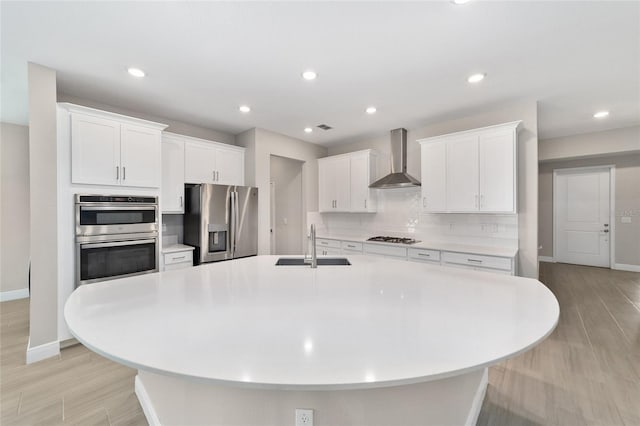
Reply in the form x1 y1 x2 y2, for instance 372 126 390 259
76 203 158 236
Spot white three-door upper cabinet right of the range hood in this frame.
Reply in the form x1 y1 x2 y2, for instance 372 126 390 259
418 121 521 213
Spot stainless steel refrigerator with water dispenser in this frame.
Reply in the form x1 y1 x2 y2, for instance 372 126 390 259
184 184 258 265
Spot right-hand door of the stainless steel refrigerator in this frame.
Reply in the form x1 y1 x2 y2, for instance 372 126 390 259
231 186 258 258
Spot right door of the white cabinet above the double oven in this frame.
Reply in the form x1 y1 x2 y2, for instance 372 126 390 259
120 124 162 188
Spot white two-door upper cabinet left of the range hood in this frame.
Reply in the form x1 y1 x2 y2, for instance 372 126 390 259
318 150 377 213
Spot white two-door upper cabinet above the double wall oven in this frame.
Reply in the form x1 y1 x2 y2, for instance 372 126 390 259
60 104 166 188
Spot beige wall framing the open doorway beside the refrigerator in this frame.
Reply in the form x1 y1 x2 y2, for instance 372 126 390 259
236 128 327 254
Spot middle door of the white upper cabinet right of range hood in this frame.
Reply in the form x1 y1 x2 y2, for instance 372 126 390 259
448 136 478 212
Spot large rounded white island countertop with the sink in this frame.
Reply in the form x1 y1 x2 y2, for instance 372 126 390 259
65 256 559 390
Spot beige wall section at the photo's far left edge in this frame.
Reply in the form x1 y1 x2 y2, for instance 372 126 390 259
0 123 30 292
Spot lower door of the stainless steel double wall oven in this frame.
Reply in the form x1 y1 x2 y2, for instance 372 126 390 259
76 234 158 287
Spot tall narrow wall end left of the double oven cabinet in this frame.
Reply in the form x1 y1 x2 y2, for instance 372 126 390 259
27 63 58 350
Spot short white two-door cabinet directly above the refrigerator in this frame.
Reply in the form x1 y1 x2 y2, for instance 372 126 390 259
184 137 244 185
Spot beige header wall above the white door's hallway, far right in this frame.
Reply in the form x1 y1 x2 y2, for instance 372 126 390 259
538 126 640 161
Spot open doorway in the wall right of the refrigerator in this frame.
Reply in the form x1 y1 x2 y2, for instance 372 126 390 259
270 155 305 255
